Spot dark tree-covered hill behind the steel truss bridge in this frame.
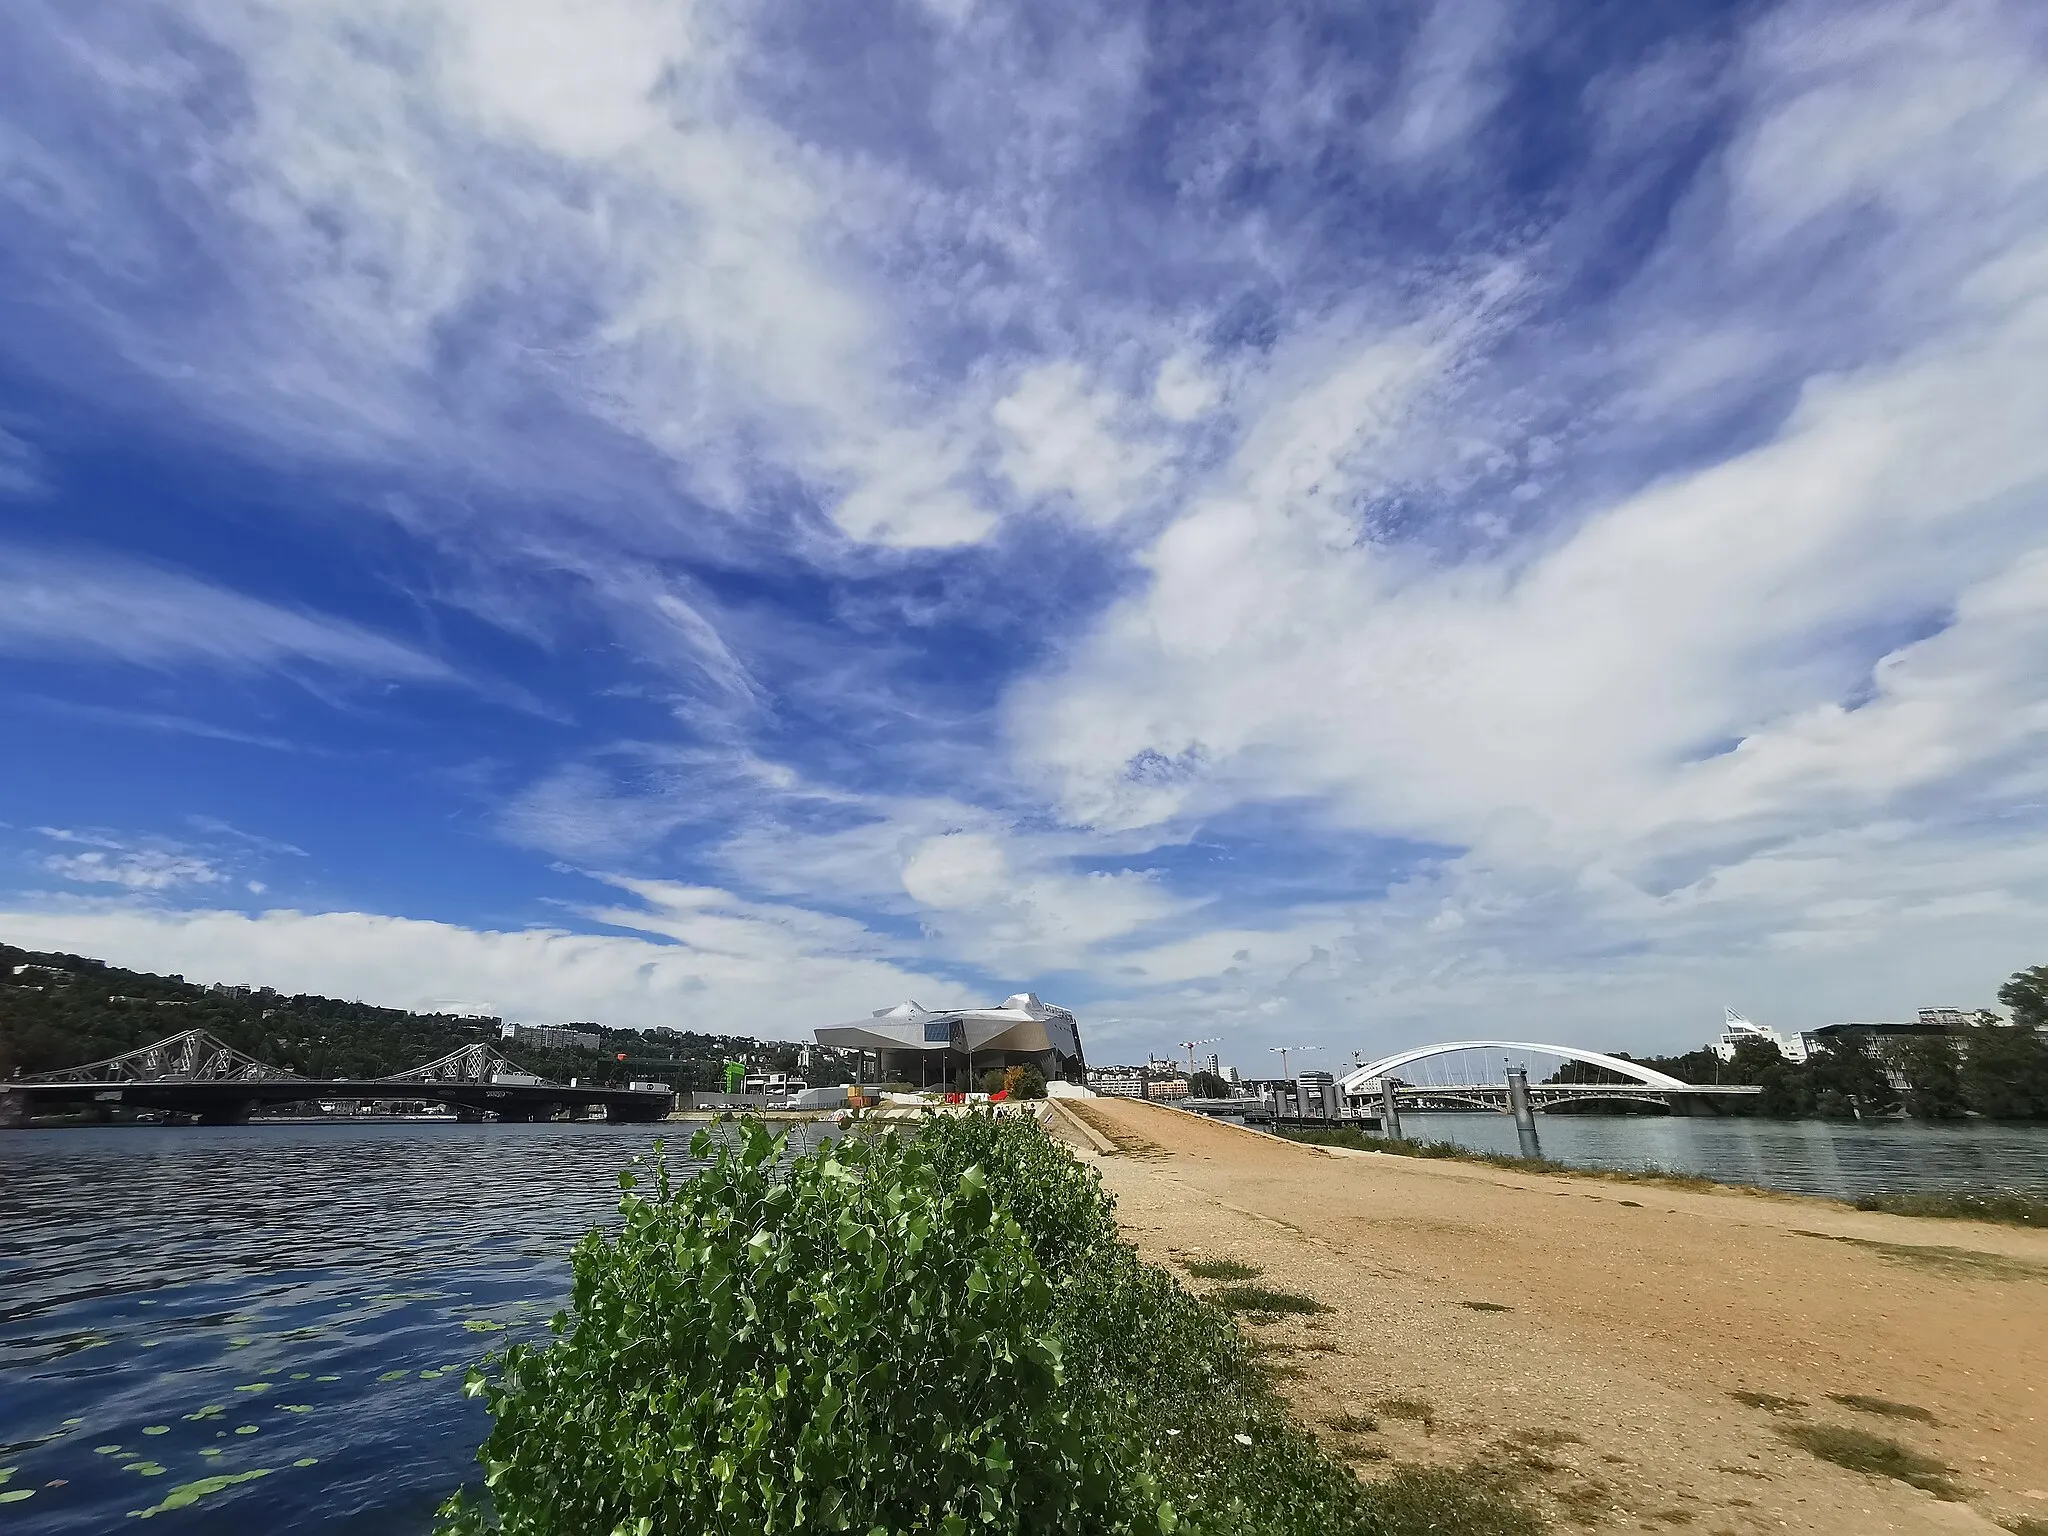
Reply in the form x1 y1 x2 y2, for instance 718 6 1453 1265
0 944 823 1090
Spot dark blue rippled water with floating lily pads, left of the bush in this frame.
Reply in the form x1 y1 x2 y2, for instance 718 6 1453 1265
0 1122 831 1536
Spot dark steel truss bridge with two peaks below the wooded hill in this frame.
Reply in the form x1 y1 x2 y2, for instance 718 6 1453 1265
0 1030 676 1126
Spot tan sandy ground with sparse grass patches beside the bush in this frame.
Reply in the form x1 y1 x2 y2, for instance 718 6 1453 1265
1055 1100 2048 1536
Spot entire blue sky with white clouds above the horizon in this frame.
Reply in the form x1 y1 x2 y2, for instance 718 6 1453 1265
0 0 2048 1069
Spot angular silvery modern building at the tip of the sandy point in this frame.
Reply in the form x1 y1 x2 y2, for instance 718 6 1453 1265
817 991 1087 1087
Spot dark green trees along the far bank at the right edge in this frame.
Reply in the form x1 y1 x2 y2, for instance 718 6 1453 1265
1645 965 2048 1120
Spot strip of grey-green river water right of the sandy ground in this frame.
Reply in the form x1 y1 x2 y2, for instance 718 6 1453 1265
1401 1114 2048 1200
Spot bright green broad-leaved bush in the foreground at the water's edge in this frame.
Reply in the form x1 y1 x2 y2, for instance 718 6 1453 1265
446 1126 1161 1536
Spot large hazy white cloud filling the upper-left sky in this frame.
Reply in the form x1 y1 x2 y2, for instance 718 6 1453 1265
0 0 1163 547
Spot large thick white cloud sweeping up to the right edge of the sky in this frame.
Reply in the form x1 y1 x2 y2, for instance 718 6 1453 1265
1012 0 2048 876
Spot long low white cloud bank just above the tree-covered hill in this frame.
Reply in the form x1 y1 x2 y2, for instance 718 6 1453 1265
0 889 965 1040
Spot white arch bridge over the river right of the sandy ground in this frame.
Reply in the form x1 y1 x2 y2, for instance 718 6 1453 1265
1337 1040 1763 1112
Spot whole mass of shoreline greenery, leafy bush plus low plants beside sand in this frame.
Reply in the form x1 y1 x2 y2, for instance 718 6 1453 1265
438 1114 1542 1536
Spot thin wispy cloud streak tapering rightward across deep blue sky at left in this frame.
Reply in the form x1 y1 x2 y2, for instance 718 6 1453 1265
0 545 457 682
